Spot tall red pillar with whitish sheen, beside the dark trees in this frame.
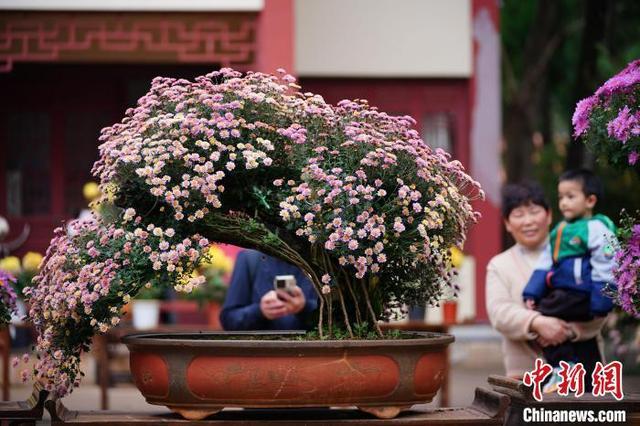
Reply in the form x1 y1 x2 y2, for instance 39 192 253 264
468 0 502 322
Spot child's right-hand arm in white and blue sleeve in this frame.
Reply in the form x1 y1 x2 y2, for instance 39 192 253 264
588 220 616 317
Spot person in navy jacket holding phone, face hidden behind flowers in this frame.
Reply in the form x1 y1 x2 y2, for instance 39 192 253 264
220 250 318 330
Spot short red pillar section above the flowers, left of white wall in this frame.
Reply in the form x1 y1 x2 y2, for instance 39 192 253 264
256 0 295 74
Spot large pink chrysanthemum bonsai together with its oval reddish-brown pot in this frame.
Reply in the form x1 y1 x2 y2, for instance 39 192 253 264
27 69 483 418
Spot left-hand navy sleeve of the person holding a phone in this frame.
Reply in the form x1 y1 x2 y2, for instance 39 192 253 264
220 251 266 331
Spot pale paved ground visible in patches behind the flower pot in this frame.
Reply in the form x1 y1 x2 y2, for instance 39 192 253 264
6 326 640 418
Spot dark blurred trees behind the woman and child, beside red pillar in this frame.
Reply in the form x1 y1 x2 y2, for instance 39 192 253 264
501 0 640 223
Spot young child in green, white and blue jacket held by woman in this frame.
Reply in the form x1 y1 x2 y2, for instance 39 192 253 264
523 170 615 392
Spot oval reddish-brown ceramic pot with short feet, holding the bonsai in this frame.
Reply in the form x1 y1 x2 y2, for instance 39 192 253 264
123 332 453 420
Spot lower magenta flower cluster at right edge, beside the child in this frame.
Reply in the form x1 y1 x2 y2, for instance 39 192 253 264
613 224 640 318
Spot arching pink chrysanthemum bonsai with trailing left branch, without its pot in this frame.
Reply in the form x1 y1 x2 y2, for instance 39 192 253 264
27 69 482 395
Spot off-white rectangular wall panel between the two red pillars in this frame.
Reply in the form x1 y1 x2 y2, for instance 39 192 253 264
295 0 472 77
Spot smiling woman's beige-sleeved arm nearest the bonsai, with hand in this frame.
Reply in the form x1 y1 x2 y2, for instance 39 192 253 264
486 262 540 340
